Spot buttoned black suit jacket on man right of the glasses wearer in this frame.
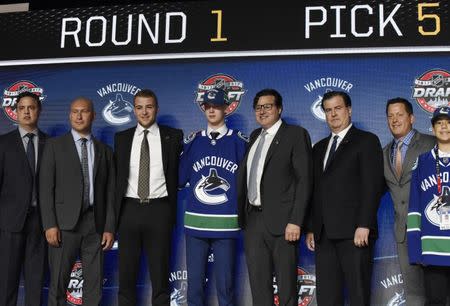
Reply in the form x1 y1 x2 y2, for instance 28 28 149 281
310 126 384 241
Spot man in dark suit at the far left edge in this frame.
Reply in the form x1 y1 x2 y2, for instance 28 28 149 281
0 92 47 306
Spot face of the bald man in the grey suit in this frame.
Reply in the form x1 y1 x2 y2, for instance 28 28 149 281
69 98 95 136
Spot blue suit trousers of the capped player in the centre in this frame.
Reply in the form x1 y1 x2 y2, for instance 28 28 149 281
186 235 236 306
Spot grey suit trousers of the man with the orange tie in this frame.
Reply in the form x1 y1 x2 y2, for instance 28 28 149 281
397 240 425 306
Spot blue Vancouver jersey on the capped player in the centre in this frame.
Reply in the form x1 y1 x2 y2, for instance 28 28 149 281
179 129 246 238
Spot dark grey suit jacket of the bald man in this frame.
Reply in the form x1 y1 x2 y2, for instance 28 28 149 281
39 132 115 234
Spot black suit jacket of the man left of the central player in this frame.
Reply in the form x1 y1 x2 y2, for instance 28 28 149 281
114 125 183 224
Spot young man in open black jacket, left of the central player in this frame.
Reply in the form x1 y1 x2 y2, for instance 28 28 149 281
114 89 183 306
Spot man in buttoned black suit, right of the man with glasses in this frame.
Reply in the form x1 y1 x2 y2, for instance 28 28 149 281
306 91 384 306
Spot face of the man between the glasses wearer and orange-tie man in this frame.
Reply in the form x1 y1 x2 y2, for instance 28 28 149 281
323 96 352 134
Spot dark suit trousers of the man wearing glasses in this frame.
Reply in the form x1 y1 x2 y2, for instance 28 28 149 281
244 208 298 306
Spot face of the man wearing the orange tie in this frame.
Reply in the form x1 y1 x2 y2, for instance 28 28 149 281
387 103 415 139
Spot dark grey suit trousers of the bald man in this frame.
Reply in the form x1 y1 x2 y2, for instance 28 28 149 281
48 208 103 306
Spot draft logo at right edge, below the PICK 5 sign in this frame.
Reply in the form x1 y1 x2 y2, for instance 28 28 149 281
412 69 450 113
